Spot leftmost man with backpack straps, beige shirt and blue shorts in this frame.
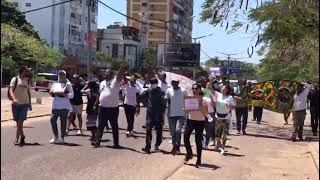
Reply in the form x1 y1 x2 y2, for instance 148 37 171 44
8 66 32 146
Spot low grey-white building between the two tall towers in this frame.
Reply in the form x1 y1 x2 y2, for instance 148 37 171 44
97 23 142 69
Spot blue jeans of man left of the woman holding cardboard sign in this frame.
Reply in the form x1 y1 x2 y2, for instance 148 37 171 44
169 116 185 148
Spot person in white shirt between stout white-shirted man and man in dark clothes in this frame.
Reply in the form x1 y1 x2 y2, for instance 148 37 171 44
124 75 140 137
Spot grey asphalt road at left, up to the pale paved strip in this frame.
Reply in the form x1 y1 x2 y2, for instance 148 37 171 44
1 110 184 179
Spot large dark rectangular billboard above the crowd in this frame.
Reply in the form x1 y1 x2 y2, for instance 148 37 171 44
157 43 200 67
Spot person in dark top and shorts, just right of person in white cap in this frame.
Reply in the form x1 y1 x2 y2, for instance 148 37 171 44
66 74 85 136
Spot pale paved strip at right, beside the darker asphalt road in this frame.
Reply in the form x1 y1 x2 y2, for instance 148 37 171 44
168 111 319 180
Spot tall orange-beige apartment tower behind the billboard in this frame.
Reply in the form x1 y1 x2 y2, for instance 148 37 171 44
127 0 193 48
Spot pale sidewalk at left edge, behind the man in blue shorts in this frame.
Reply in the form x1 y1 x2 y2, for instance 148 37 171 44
1 97 86 122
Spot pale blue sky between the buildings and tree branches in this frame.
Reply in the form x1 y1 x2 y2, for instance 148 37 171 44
98 0 262 64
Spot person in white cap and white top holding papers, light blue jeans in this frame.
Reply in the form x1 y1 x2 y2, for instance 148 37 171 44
49 70 74 144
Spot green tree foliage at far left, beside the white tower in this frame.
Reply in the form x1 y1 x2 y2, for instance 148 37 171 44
1 0 64 68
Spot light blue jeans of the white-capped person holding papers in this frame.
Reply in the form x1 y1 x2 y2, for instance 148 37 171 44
50 109 69 138
